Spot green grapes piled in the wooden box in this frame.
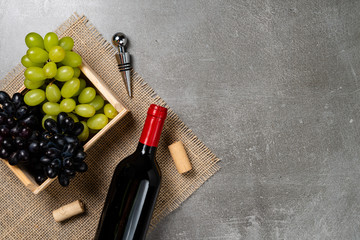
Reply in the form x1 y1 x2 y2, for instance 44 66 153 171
21 32 118 141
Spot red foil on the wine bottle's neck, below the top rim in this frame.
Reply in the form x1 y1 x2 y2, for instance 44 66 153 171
139 110 165 147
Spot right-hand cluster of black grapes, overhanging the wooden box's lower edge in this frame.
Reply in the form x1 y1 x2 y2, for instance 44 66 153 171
40 112 88 187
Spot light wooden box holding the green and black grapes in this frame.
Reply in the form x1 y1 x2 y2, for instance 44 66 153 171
1 61 129 194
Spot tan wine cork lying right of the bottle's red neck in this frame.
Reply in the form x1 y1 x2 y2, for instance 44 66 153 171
169 141 192 173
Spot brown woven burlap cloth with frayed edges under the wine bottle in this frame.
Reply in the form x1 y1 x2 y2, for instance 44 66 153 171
0 14 219 239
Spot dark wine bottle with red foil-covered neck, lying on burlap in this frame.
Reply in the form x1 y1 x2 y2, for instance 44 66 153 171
95 104 167 240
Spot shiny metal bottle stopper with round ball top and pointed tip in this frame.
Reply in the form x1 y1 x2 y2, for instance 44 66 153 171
112 32 132 97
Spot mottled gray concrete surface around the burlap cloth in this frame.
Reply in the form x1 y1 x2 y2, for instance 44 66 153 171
0 0 360 240
